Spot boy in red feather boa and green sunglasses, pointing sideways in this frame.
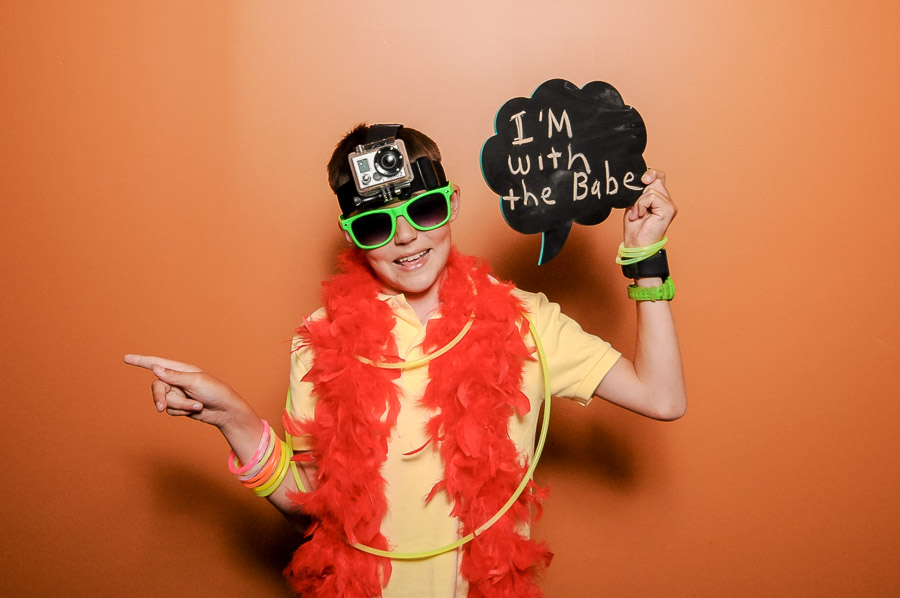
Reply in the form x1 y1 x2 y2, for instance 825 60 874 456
125 125 686 598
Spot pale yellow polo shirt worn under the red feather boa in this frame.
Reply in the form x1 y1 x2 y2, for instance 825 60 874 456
291 290 620 598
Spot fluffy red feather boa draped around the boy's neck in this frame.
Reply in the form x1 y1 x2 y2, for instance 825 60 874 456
285 250 552 598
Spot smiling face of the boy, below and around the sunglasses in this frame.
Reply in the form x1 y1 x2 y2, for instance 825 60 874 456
344 189 459 299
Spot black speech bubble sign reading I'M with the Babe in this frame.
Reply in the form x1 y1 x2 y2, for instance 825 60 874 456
481 79 647 264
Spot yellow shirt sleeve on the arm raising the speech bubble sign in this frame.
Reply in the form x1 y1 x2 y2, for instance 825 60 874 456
516 290 622 405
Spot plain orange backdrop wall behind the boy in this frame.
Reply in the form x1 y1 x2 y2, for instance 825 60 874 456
0 0 900 597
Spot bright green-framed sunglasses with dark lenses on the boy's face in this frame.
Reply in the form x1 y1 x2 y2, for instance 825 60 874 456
340 182 453 249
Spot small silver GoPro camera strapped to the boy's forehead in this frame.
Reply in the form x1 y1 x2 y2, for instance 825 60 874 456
348 138 413 198
